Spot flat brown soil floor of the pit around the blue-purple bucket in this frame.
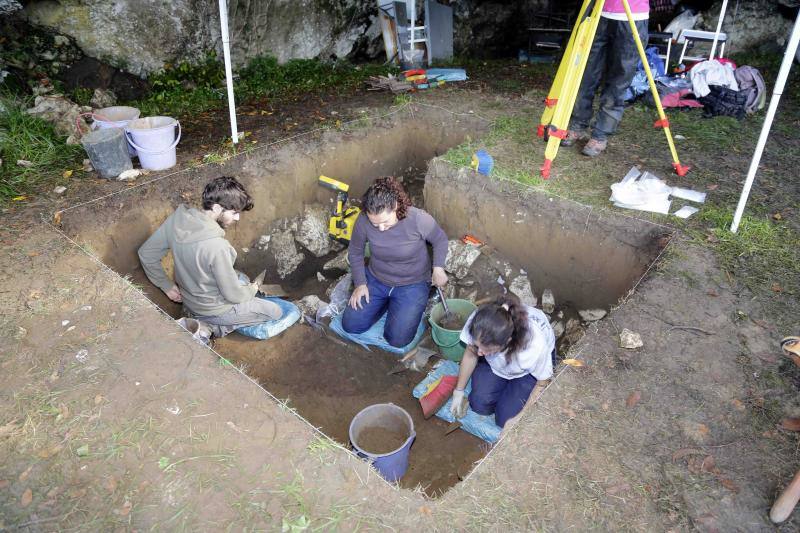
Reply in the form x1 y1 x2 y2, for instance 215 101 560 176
216 324 488 496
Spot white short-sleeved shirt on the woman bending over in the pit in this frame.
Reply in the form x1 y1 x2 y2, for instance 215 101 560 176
461 305 556 381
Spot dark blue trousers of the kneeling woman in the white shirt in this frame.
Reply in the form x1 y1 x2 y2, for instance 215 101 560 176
469 357 536 427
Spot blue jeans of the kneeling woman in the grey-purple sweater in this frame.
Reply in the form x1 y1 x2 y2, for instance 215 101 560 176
342 269 431 348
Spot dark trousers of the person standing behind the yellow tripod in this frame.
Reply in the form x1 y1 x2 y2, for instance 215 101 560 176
570 17 648 141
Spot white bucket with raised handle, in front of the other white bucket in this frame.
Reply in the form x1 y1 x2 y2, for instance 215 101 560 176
125 117 181 170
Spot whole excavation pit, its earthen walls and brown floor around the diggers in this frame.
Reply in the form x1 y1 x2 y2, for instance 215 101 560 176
56 114 669 497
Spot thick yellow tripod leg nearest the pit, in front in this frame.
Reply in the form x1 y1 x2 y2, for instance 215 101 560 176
540 0 605 179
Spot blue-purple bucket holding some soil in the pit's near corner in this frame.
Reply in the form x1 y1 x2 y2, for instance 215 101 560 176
350 403 417 483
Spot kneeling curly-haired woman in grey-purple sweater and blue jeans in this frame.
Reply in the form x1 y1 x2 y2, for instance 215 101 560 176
342 177 447 348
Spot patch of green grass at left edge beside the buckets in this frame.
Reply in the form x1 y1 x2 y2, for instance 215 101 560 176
0 98 84 202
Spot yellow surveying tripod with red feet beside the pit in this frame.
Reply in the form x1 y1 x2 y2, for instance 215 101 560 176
536 0 689 179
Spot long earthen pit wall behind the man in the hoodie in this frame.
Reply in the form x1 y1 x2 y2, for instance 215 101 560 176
60 110 486 314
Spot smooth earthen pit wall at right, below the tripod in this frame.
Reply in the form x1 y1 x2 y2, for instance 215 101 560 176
425 159 672 309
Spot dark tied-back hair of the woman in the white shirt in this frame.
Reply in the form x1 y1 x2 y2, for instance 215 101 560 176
469 293 531 363
